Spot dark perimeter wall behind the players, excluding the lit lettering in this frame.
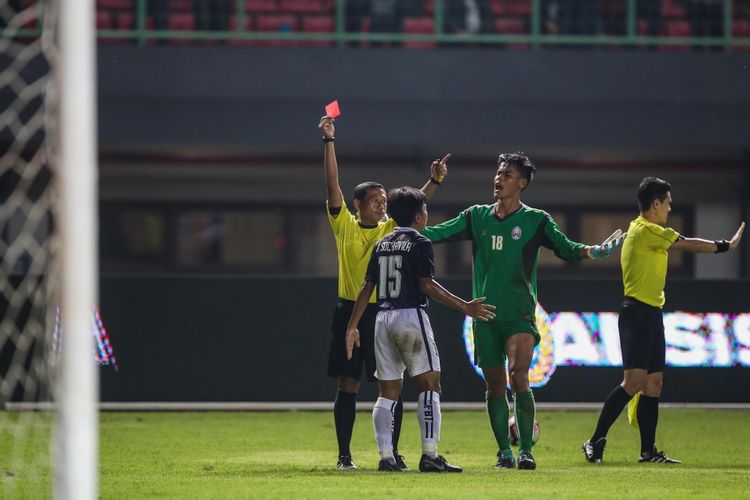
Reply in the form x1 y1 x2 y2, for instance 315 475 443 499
100 277 750 402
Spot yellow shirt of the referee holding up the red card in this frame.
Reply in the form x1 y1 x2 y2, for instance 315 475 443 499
326 201 396 303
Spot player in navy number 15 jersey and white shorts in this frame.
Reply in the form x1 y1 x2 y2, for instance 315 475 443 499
346 187 495 472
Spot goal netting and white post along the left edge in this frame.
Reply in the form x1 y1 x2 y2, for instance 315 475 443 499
0 0 97 498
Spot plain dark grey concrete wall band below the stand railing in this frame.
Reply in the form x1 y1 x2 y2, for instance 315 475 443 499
98 46 750 157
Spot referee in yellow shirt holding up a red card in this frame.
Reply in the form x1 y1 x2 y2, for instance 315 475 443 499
318 116 450 470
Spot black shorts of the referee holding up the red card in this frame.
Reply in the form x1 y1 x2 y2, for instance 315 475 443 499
328 299 378 382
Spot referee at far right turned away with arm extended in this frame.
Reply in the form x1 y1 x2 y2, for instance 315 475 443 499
583 177 745 464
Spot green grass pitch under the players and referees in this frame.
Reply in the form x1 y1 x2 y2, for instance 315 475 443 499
0 409 750 499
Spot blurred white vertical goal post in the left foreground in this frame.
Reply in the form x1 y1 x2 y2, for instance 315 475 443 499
55 0 99 500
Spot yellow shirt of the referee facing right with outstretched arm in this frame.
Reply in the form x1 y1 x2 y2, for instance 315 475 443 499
620 215 680 307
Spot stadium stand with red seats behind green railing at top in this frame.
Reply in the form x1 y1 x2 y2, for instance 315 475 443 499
0 0 750 52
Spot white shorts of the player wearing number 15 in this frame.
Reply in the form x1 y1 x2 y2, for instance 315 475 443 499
375 309 440 380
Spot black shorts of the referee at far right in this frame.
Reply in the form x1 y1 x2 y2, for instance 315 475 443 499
617 297 666 373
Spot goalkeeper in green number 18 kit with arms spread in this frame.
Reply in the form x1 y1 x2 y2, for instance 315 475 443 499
423 153 624 469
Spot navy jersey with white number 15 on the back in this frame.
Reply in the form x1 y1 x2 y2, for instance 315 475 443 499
365 227 435 309
